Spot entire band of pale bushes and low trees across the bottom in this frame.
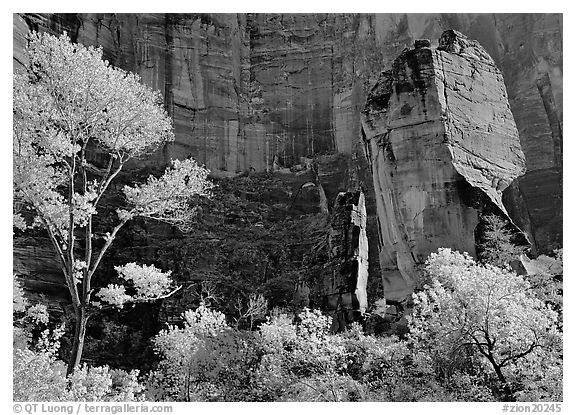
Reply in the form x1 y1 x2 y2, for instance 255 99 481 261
14 244 562 401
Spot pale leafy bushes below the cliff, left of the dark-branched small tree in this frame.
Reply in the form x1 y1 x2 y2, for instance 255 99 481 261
148 307 497 401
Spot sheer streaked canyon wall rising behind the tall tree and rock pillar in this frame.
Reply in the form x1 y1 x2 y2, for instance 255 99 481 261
13 13 563 308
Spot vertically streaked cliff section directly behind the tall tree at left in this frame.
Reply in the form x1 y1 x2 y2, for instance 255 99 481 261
14 13 260 175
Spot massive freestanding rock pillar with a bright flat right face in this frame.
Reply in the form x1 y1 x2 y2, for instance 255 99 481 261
363 31 524 300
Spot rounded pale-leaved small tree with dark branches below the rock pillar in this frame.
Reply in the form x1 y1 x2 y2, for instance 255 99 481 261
409 249 562 400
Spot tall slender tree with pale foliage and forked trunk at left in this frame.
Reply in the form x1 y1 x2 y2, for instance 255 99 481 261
13 33 212 373
